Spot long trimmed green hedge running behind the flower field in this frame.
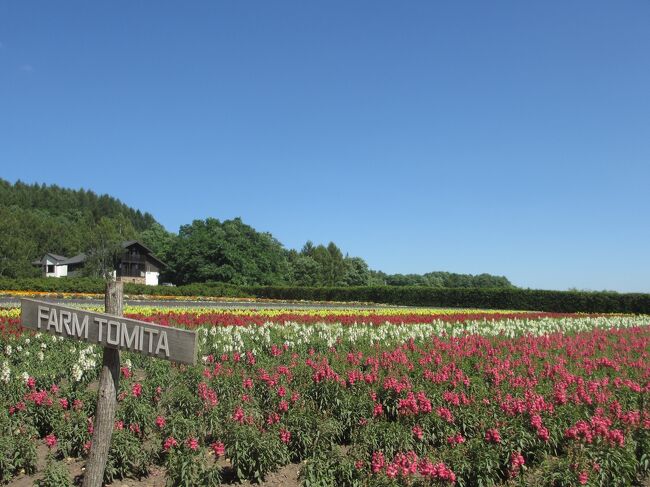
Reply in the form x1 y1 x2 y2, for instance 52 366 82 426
0 278 650 314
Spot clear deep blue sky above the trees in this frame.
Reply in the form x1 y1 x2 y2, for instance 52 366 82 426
0 0 650 292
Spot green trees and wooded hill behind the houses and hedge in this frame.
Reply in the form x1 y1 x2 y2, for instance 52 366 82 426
0 179 513 288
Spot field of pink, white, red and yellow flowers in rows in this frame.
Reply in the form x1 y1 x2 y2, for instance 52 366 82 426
0 307 650 486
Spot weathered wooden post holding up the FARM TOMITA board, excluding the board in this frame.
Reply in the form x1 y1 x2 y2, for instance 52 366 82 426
83 281 124 487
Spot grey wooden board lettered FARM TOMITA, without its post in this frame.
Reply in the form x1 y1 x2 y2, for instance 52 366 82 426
21 299 197 365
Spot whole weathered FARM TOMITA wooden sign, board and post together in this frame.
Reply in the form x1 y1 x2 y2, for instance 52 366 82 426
21 281 197 487
